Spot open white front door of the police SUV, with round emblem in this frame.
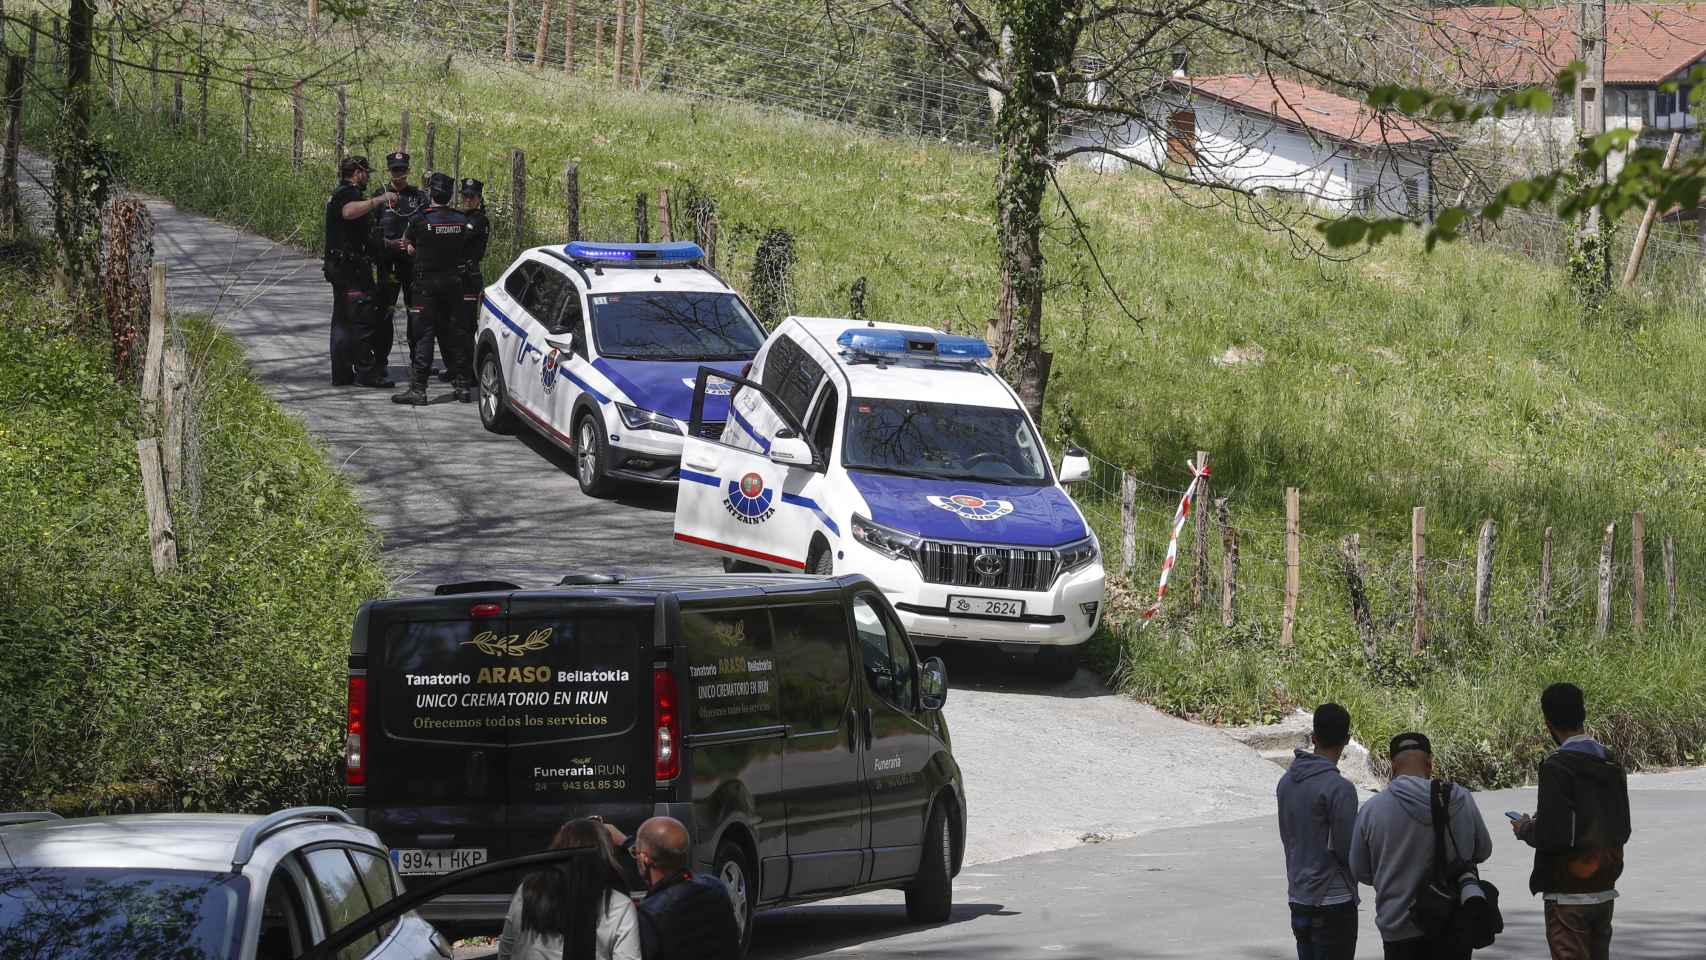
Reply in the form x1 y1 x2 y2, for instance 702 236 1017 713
676 367 824 571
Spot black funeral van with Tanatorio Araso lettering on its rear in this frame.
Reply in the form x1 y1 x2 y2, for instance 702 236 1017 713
345 575 966 938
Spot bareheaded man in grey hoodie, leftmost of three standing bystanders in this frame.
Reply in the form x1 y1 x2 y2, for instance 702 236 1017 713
1274 703 1356 960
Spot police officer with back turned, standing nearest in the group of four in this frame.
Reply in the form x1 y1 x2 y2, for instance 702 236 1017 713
391 174 474 406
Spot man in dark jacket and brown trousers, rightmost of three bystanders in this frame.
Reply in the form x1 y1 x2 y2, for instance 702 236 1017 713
1512 684 1629 960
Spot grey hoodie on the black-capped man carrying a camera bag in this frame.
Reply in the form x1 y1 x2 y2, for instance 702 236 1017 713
1351 776 1493 943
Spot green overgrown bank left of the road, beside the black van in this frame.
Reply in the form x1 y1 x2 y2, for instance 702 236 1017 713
0 238 384 813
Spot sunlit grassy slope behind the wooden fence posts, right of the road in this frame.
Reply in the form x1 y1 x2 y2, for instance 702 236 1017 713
49 43 1706 781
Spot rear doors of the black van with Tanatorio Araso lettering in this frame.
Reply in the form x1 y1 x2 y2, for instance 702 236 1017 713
365 593 655 893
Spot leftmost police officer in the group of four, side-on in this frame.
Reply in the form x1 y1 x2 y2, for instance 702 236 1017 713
324 157 396 387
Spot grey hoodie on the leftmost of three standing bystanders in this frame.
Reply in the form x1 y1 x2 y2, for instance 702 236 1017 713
1274 750 1356 907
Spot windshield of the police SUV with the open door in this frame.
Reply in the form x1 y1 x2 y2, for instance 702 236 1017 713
843 397 1049 486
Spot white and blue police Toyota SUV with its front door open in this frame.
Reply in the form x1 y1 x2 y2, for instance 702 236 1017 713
676 317 1104 679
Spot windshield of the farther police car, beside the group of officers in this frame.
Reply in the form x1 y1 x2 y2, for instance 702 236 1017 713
592 290 764 360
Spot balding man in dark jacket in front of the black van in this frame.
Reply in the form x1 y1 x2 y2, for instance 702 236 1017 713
609 817 747 960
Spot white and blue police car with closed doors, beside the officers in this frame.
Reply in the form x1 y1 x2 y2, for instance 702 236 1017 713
474 242 764 496
